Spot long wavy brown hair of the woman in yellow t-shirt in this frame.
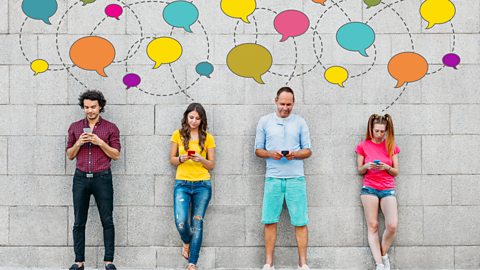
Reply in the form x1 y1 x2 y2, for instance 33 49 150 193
180 103 208 152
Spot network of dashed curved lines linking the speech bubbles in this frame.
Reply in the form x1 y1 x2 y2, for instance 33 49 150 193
19 0 456 109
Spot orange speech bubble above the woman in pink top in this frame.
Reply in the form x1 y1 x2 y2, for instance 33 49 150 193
388 52 428 88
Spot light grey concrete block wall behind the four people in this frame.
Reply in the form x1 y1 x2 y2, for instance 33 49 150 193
0 0 480 269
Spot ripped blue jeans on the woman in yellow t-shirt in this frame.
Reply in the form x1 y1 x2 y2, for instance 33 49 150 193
173 180 212 264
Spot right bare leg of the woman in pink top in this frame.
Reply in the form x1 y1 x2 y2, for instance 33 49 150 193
380 196 398 256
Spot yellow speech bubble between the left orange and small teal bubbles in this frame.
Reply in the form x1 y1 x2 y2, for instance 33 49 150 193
147 37 182 69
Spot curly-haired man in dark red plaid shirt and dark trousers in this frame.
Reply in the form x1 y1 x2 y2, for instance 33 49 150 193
67 90 120 270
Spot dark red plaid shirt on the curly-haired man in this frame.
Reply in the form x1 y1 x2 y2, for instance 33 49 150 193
67 117 121 172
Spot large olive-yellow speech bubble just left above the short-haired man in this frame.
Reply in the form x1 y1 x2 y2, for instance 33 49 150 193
227 43 273 84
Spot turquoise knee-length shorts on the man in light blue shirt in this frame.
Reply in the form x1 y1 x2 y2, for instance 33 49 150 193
262 176 308 226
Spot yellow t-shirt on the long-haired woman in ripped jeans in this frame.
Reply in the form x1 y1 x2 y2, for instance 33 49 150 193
170 130 215 181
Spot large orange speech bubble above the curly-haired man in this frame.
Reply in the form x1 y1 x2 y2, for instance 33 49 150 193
70 36 115 77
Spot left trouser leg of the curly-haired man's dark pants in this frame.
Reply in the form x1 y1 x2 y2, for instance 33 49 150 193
72 176 91 264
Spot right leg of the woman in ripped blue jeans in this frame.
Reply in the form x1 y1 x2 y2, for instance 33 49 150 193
188 181 212 265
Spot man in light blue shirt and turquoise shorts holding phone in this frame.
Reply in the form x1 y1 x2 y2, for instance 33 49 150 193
255 87 312 270
